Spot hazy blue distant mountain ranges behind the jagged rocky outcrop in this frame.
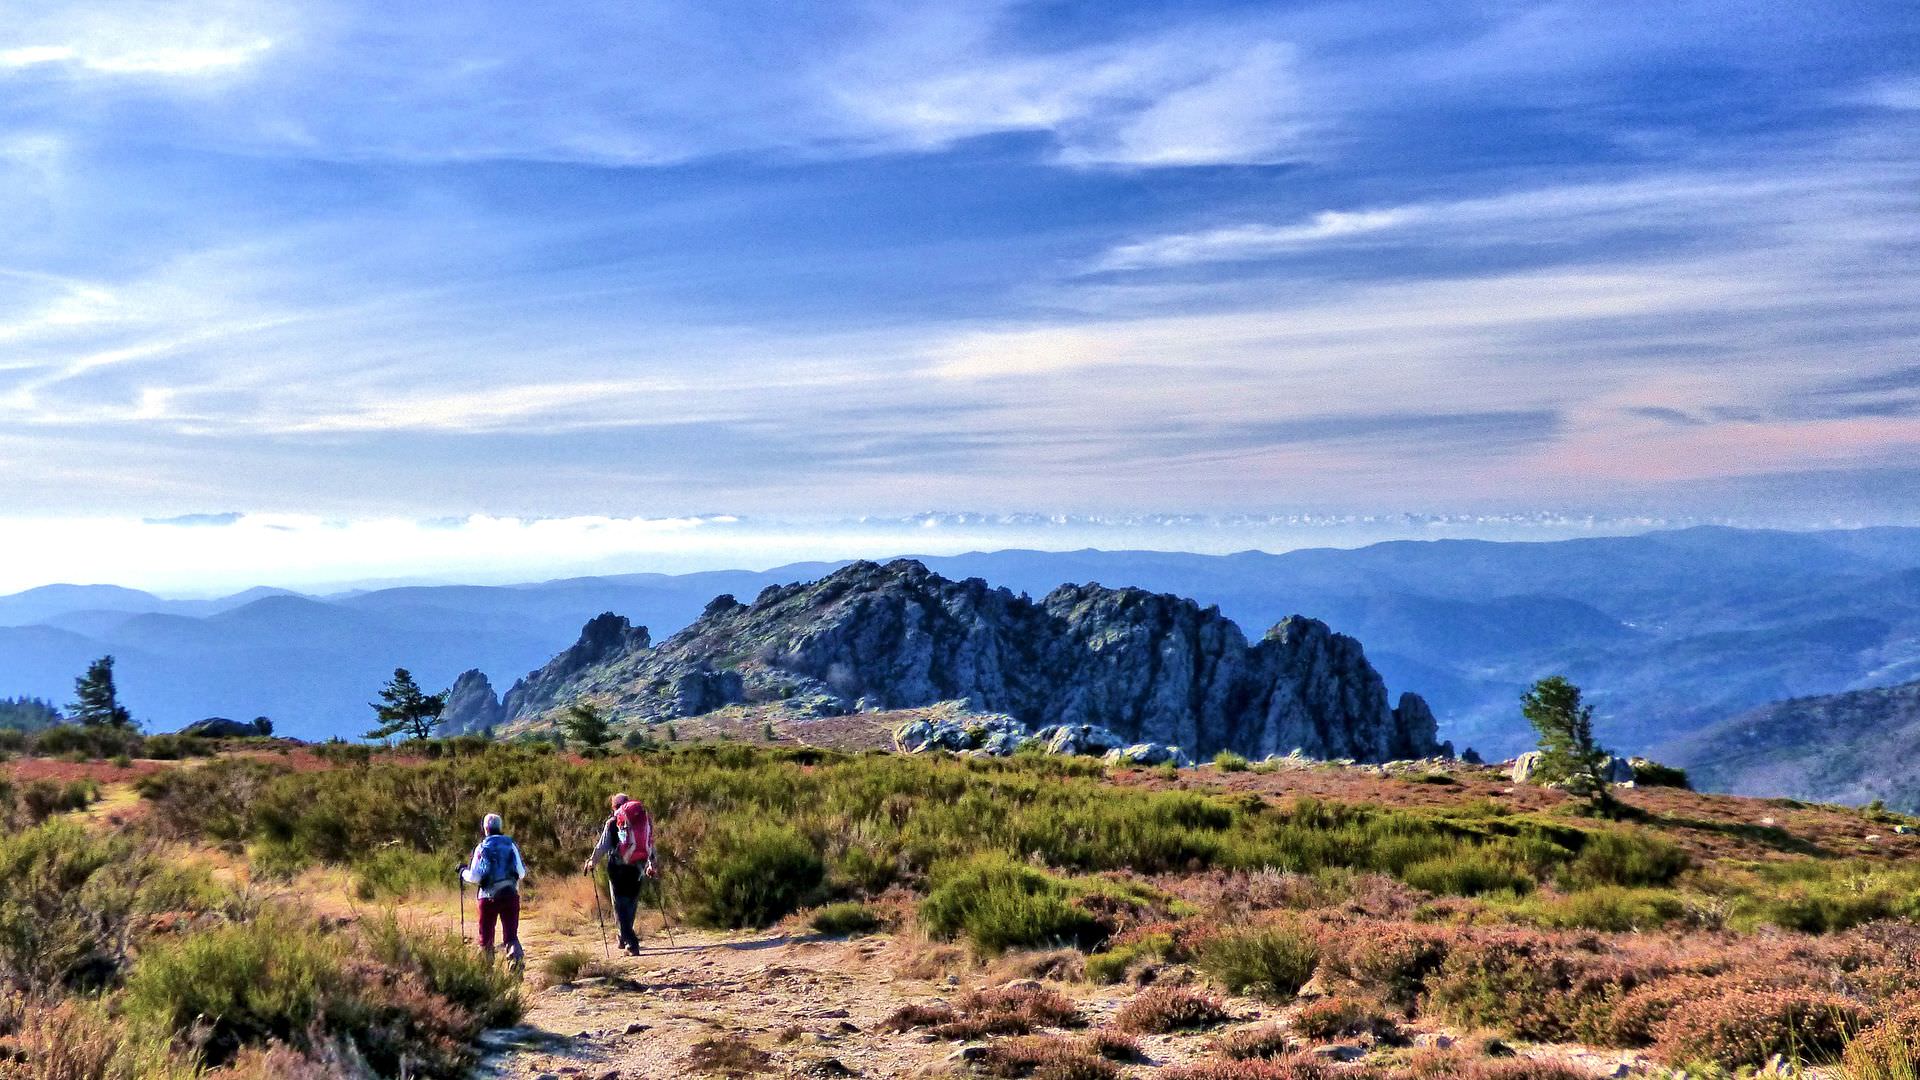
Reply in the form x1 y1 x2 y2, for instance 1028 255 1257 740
11 527 1920 769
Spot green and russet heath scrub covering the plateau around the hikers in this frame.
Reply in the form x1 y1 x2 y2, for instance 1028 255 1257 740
0 740 1920 1080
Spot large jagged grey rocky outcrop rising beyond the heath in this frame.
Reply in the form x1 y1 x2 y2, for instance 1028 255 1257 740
503 559 1444 761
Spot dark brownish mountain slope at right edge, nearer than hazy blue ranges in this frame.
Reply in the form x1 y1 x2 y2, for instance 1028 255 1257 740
1668 682 1920 811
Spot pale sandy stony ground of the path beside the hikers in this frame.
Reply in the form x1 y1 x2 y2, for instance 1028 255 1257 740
468 907 1663 1080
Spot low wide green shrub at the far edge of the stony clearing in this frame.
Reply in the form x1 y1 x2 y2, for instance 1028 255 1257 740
920 855 1106 955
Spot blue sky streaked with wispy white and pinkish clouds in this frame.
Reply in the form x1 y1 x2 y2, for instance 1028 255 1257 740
0 0 1920 580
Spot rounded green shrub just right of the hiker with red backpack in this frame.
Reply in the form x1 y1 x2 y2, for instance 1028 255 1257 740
680 824 826 928
